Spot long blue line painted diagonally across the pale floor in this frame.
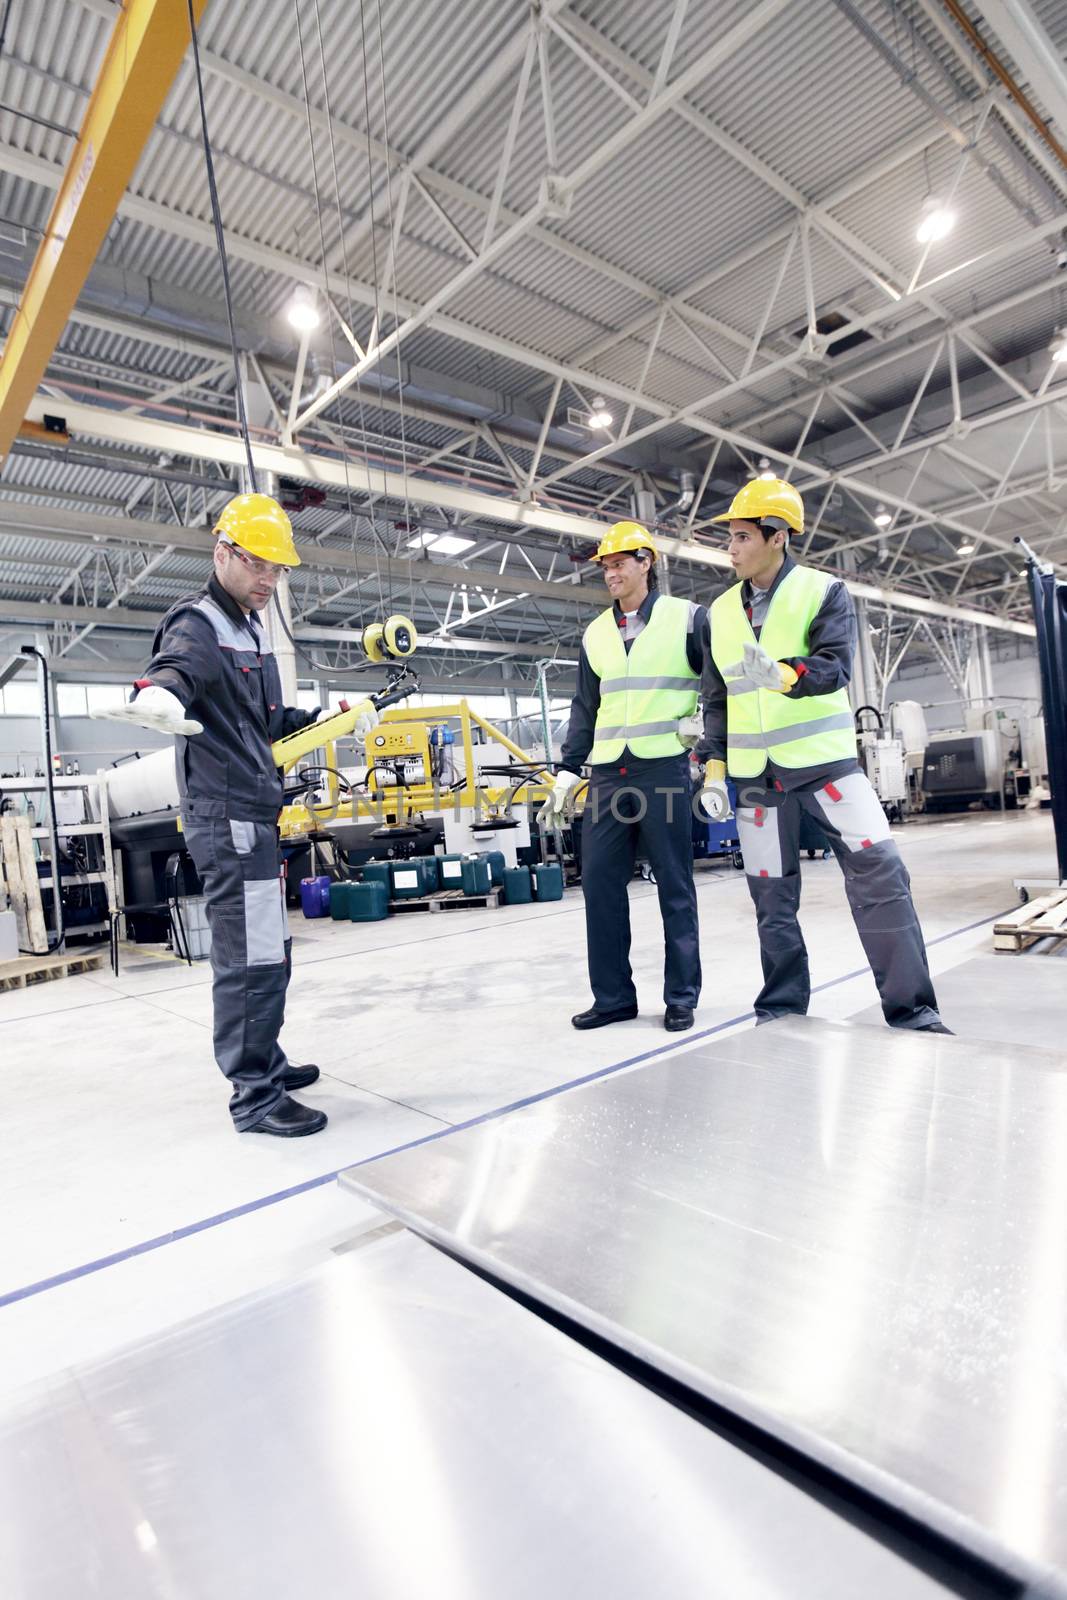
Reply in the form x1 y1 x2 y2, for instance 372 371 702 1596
0 912 1003 1310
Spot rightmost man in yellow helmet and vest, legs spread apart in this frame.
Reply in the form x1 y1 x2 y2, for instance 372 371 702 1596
697 478 949 1034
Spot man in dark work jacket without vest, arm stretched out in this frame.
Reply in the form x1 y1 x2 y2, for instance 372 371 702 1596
97 494 378 1138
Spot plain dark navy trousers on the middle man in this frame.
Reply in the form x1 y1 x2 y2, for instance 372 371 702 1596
582 755 701 1011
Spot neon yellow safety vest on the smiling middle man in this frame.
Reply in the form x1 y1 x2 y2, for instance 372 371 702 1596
582 595 699 766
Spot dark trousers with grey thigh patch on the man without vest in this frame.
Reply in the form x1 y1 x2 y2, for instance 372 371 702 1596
184 819 290 1133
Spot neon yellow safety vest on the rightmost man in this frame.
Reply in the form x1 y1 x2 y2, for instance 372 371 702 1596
710 566 856 778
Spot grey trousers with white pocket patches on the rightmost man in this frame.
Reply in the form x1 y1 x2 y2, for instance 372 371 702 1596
737 773 939 1027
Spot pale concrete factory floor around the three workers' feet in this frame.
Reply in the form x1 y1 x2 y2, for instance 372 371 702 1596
0 813 1062 1392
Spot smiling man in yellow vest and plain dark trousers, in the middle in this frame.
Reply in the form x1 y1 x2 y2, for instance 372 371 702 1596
537 522 707 1032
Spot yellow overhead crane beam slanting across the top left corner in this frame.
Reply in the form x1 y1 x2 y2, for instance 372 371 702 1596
0 0 208 458
